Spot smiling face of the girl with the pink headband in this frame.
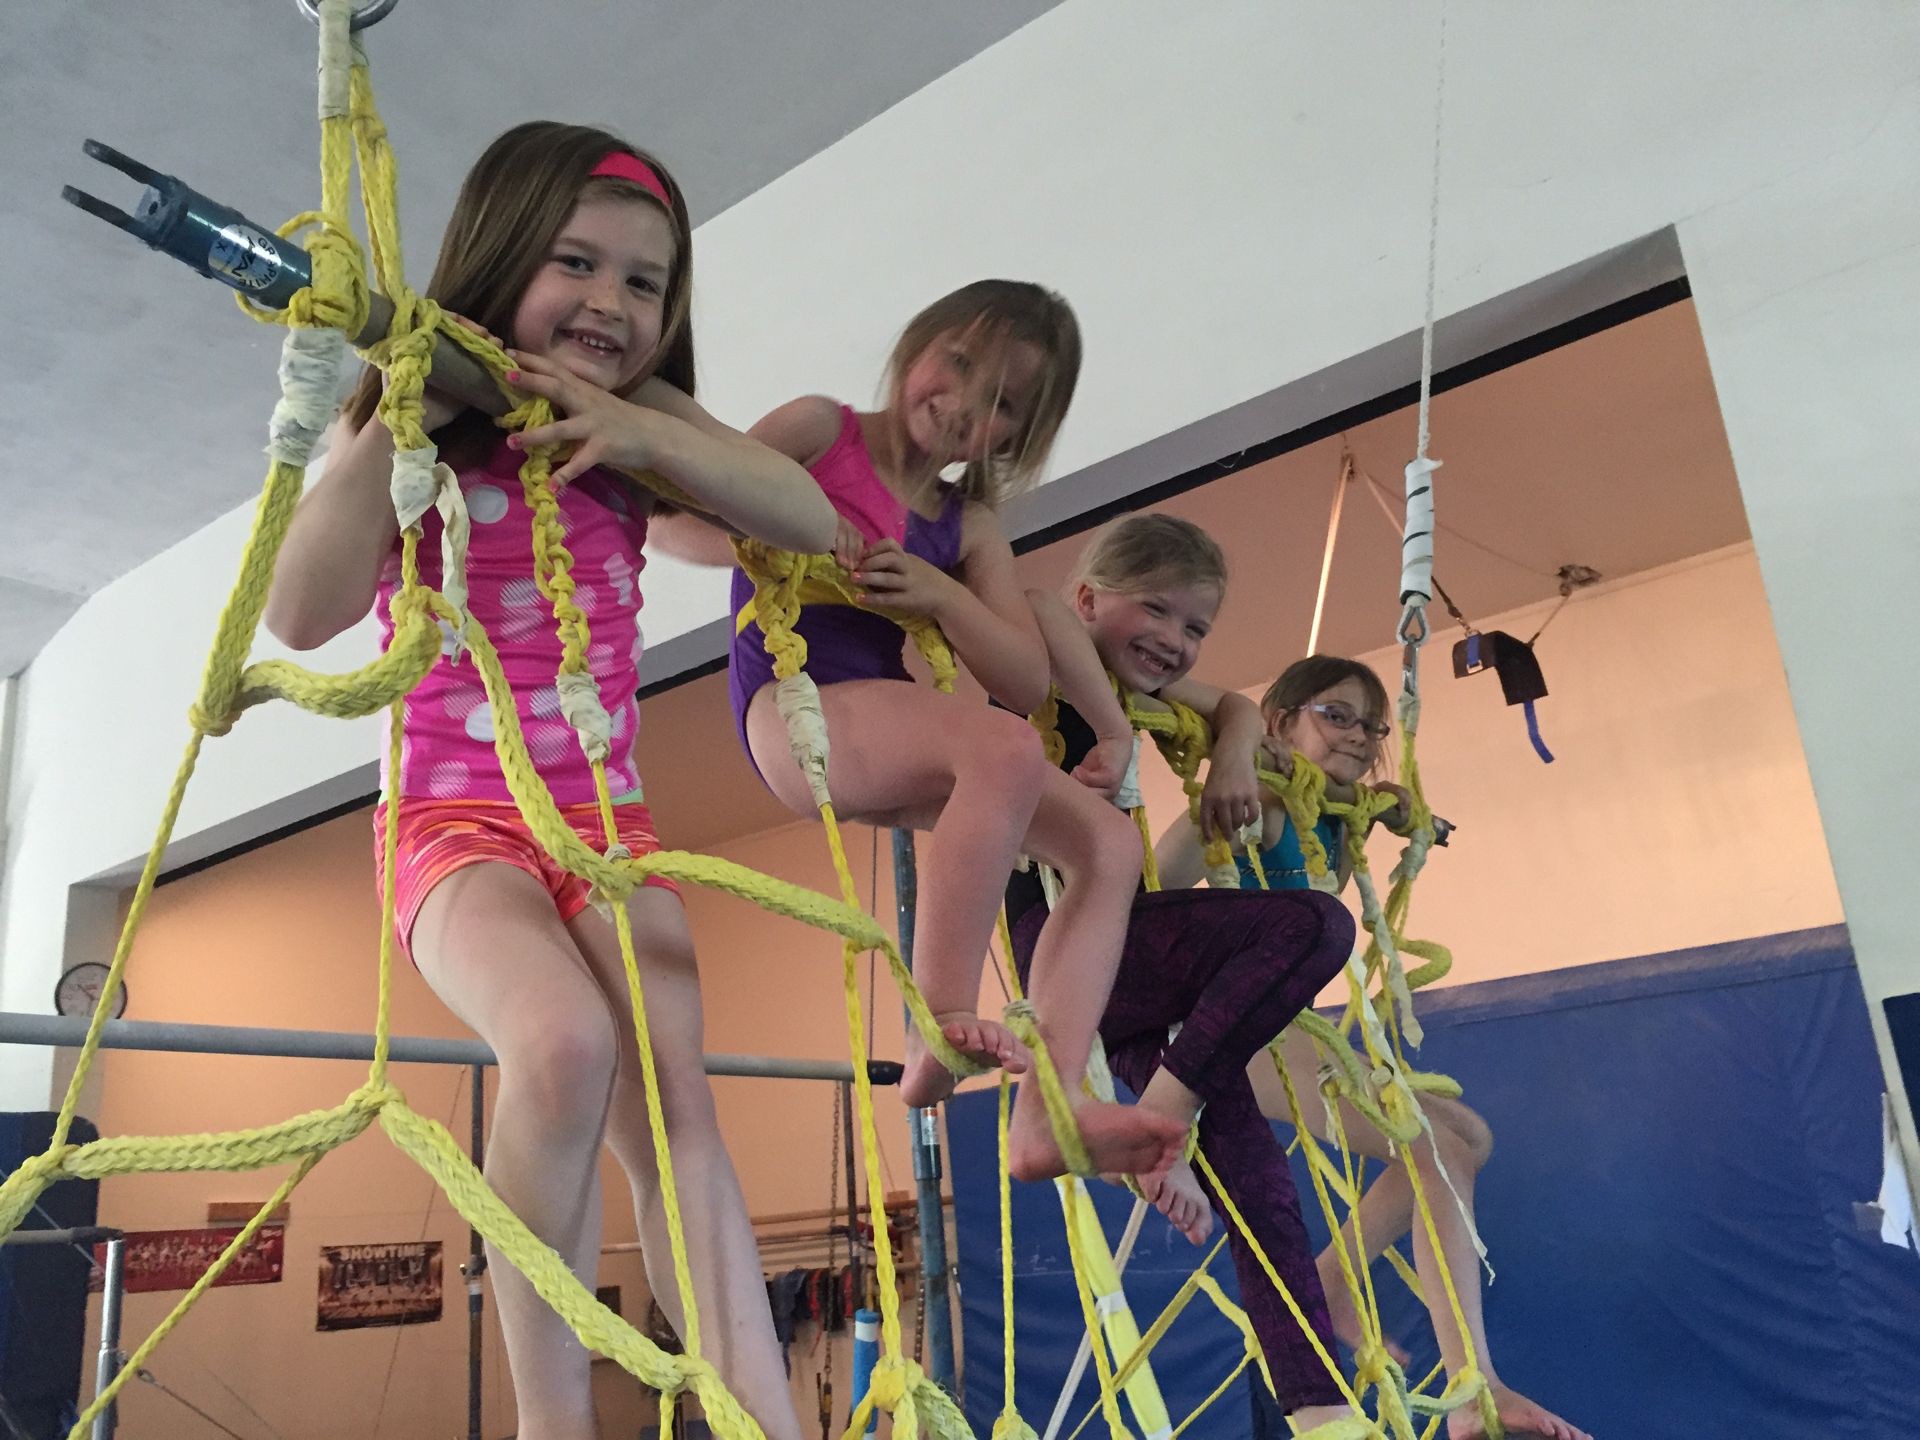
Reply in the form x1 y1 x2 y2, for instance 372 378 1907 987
511 194 678 394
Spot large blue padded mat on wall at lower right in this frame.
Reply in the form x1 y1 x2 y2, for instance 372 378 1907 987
947 927 1920 1440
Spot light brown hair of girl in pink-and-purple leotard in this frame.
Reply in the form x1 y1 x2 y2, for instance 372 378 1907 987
881 280 1081 505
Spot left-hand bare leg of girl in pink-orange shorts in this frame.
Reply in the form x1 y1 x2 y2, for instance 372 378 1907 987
411 862 614 1440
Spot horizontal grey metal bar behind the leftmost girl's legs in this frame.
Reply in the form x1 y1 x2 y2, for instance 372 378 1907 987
0 1010 900 1085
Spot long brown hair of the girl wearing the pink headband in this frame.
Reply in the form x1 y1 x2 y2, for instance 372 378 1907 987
346 121 693 468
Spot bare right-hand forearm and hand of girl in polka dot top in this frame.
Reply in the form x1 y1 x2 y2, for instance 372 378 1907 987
507 351 839 555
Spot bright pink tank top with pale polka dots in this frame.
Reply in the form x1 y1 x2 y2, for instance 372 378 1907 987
374 444 647 804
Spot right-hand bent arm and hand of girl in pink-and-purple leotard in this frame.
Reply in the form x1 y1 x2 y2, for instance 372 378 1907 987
852 501 1046 714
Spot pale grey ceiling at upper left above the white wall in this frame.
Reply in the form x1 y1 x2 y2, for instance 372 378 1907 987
0 0 1058 676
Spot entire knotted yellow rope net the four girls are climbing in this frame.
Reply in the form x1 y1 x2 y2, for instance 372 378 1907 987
0 11 1498 1440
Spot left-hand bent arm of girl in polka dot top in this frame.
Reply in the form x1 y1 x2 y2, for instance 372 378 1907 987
263 408 399 651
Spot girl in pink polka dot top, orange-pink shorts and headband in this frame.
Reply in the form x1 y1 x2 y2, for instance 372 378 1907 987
267 123 835 1440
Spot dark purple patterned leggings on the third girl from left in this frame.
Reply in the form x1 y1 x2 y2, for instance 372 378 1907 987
1014 889 1354 1409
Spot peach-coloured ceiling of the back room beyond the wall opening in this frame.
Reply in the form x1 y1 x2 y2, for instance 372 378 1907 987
641 301 1747 851
